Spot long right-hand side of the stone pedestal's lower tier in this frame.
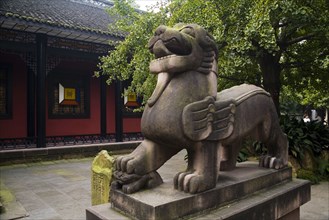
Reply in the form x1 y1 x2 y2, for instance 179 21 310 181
189 179 311 220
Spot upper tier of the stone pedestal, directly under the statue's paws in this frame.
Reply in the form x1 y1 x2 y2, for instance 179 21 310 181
87 162 310 219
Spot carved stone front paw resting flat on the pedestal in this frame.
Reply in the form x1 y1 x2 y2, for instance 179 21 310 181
174 172 216 194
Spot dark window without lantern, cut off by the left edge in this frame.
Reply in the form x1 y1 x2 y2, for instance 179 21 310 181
0 63 12 119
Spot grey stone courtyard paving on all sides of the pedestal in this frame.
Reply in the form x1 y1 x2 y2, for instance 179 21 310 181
0 151 329 220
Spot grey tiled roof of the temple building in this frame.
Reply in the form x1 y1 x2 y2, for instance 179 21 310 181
0 0 125 45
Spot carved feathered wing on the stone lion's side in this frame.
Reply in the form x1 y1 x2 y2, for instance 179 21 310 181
182 96 235 141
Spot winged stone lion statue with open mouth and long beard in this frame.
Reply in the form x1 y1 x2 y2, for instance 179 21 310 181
113 24 288 193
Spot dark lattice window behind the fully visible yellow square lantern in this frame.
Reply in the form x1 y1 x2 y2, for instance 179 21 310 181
48 73 90 118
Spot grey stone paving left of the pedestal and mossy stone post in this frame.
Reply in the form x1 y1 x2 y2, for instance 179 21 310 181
0 158 93 220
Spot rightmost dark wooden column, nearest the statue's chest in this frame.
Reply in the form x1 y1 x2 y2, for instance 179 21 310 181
115 81 123 142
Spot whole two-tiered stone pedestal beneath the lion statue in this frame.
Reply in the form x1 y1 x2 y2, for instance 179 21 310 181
86 162 310 220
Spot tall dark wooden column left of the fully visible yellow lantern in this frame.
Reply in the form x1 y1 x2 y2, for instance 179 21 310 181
36 34 47 147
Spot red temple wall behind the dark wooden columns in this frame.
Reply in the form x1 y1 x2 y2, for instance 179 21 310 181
0 54 141 138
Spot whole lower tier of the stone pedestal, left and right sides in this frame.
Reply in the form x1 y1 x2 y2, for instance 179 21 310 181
86 179 310 220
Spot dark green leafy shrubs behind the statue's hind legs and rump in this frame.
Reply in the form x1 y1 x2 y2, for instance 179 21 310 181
237 115 329 179
